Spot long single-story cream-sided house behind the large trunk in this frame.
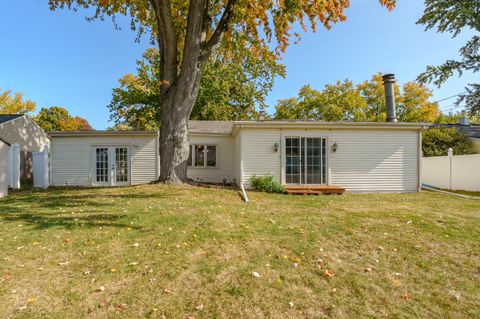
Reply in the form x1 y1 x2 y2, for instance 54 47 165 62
50 121 424 193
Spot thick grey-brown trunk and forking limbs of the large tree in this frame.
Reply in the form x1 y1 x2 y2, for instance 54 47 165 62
151 0 237 184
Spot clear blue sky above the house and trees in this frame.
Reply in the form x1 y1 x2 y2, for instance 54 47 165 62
0 0 478 129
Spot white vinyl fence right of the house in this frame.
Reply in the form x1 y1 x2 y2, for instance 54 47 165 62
422 154 480 192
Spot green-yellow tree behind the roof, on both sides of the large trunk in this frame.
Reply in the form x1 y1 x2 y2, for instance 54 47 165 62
108 48 285 130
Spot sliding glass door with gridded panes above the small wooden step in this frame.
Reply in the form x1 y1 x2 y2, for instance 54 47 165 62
285 137 327 185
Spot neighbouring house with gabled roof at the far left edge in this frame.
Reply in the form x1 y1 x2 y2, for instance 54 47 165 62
0 114 50 184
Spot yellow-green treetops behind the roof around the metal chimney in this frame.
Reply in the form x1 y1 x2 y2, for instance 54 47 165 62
275 73 439 123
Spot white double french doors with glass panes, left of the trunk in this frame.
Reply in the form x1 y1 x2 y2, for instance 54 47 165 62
92 146 130 186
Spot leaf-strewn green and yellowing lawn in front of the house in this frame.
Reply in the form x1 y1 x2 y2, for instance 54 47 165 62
0 185 480 318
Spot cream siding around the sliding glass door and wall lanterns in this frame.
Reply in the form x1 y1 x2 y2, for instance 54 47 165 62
241 128 419 193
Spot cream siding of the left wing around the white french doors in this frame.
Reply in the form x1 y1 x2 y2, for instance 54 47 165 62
50 135 158 186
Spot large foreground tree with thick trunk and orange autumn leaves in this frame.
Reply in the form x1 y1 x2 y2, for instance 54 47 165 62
48 0 395 183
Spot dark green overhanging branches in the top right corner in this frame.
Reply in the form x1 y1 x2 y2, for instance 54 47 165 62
417 0 480 114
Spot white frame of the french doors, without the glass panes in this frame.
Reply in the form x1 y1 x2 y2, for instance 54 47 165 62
91 145 132 186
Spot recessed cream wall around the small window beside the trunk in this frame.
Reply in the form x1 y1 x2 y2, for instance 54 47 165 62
187 134 235 183
